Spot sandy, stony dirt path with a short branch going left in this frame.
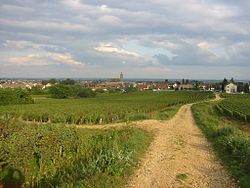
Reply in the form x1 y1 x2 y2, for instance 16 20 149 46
77 96 236 188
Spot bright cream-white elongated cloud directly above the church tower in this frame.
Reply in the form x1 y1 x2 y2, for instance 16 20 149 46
94 42 143 58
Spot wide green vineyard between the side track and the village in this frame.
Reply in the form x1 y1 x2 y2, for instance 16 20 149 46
0 91 214 124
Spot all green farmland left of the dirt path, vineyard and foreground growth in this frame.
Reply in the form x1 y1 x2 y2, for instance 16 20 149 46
0 92 214 187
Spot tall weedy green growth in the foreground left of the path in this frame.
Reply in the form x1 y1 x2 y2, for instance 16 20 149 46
0 120 153 187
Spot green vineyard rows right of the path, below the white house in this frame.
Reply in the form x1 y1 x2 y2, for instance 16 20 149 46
216 94 250 122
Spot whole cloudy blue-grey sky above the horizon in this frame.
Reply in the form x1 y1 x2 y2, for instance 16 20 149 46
0 0 250 80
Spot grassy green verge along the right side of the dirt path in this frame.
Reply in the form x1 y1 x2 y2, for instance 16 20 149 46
192 102 250 188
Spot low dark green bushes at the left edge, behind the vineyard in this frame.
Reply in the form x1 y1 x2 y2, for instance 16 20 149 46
0 88 34 105
